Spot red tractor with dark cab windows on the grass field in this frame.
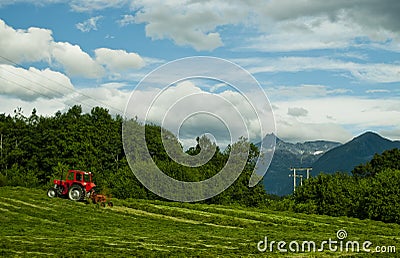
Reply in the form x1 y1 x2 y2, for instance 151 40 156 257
47 170 96 201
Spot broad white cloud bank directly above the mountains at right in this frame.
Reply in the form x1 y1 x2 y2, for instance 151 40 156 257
273 96 400 142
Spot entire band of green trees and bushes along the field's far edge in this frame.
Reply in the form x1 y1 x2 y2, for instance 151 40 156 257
0 106 400 223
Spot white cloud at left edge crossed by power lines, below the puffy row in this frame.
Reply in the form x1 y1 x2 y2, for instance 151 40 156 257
0 64 74 101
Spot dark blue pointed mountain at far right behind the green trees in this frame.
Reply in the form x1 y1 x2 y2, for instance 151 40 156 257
313 132 400 173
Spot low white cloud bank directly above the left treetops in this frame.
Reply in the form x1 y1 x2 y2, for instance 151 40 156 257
0 80 131 116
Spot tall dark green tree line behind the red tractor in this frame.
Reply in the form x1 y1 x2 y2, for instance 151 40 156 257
0 105 267 206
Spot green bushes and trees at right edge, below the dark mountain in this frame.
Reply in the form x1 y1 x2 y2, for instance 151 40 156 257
293 149 400 223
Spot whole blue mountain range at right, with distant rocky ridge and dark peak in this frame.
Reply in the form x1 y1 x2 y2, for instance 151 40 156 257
258 132 400 196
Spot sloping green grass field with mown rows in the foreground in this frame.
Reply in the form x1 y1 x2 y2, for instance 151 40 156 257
0 187 400 257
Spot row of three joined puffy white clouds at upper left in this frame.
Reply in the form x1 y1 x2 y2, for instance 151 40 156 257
0 20 145 78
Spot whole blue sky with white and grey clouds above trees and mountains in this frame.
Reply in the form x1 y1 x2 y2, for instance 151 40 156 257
0 0 400 145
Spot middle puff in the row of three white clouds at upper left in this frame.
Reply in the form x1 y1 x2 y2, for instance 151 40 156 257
52 42 104 78
